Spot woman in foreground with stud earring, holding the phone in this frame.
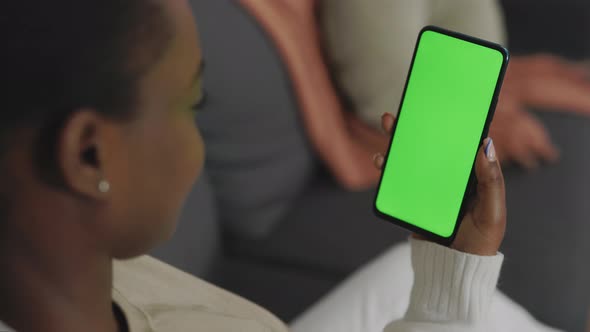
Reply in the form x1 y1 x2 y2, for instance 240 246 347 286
0 0 560 332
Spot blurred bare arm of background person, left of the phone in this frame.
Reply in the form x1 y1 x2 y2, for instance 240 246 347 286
240 0 382 191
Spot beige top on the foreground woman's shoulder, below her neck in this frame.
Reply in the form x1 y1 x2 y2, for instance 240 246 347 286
113 256 288 332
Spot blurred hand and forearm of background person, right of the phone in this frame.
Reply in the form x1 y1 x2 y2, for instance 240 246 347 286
490 54 590 169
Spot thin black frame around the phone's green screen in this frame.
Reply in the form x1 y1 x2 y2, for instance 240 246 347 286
373 25 510 245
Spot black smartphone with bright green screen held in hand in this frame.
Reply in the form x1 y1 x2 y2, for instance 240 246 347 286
373 26 510 244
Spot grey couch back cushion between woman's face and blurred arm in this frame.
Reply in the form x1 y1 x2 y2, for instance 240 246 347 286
192 0 315 237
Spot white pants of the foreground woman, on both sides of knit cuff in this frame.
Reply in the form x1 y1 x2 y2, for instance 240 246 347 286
291 244 555 332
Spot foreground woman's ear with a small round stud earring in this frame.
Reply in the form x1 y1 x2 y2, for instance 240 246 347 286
55 109 112 199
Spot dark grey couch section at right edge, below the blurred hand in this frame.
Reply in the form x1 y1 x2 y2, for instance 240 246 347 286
499 112 590 331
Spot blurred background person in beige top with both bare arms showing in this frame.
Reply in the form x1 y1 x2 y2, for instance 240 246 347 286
242 0 590 190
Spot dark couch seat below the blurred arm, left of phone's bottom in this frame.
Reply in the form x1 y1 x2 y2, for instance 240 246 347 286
227 177 409 280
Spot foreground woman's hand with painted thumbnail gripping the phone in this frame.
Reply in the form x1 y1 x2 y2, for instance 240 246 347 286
374 113 506 256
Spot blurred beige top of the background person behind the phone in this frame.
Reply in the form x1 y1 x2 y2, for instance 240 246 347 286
320 0 506 128
